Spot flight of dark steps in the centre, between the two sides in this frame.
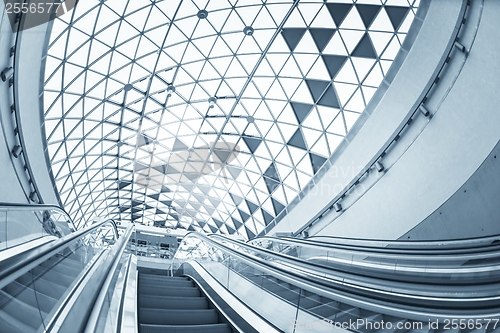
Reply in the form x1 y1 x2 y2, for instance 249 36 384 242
138 268 232 333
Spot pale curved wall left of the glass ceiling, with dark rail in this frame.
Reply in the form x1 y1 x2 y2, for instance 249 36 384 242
0 2 59 205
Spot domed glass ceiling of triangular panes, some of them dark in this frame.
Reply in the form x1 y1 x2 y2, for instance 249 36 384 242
43 0 418 238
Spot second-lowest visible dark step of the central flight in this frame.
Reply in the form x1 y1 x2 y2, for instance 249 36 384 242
139 308 219 325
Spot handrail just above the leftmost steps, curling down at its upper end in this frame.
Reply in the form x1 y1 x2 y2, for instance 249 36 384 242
0 219 118 289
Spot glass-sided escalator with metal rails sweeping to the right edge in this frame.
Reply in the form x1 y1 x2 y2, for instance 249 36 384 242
174 233 500 332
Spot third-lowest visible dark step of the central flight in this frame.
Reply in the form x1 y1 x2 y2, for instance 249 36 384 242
139 295 208 309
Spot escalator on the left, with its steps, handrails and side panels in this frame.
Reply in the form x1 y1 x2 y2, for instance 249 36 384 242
0 205 124 333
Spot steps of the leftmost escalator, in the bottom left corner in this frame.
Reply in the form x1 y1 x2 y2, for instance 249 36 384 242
0 254 84 333
